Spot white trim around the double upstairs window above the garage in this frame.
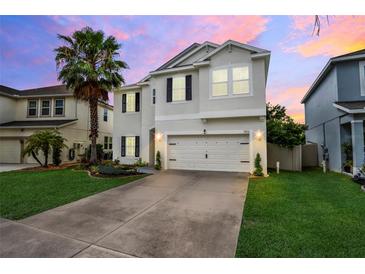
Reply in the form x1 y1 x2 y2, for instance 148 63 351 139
209 63 253 100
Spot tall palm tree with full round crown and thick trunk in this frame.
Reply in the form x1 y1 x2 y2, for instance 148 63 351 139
55 27 128 163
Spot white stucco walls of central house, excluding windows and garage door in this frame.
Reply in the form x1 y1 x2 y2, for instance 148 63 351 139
113 41 270 173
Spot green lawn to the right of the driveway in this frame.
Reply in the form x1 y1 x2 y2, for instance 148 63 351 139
236 169 365 258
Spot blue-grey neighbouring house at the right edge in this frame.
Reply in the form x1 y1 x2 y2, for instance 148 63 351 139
302 49 365 172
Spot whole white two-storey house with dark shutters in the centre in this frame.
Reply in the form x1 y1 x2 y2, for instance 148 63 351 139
113 40 270 173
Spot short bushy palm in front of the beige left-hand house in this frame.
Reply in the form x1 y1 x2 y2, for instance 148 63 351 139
23 129 67 167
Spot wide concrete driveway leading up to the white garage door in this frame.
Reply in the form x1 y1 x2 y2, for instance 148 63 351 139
0 170 248 257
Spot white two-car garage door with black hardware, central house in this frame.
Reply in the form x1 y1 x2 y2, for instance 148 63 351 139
167 135 250 172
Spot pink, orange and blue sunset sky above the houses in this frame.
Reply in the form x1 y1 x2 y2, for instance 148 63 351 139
0 16 365 122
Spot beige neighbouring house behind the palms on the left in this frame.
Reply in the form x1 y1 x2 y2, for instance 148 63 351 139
0 85 113 163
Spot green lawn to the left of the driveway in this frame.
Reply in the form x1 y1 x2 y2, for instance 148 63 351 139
0 169 143 220
